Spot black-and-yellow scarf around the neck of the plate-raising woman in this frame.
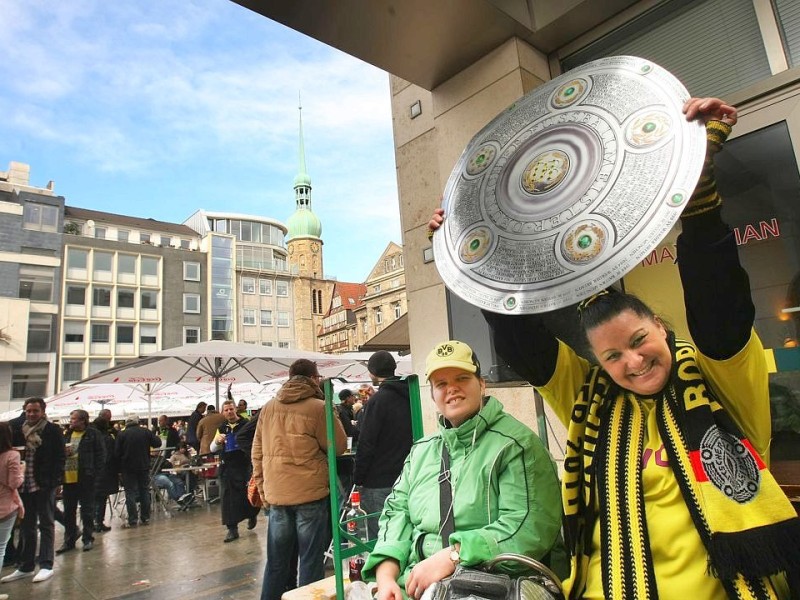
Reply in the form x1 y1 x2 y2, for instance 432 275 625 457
562 336 800 599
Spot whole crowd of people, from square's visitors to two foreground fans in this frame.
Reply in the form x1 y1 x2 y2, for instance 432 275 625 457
0 98 800 600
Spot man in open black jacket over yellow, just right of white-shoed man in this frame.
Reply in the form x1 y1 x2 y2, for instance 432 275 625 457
56 409 106 554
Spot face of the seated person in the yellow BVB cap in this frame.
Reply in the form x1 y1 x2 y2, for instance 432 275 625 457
429 367 486 427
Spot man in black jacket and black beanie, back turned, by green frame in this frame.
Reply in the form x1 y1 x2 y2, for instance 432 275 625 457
353 350 413 539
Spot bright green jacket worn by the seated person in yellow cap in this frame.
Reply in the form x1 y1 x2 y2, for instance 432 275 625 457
363 397 561 587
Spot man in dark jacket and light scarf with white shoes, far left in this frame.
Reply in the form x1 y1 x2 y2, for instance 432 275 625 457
0 398 65 583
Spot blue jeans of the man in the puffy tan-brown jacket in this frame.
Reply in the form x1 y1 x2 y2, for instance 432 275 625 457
261 496 330 600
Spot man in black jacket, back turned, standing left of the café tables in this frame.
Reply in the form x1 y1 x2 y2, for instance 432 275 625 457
115 416 161 528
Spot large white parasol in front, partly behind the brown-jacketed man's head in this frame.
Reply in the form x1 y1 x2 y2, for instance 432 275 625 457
75 341 369 406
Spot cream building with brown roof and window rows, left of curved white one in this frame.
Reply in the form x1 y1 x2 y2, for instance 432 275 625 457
56 206 209 389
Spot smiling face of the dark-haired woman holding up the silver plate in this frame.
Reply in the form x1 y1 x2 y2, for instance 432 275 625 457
586 310 672 396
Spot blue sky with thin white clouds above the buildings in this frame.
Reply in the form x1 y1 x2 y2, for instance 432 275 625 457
0 0 401 281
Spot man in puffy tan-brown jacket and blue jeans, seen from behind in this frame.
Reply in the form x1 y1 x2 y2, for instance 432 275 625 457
252 359 347 600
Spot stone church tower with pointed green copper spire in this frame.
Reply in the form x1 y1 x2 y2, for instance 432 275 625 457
286 99 334 351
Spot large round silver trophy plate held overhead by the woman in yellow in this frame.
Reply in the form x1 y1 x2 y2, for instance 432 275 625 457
433 56 706 314
